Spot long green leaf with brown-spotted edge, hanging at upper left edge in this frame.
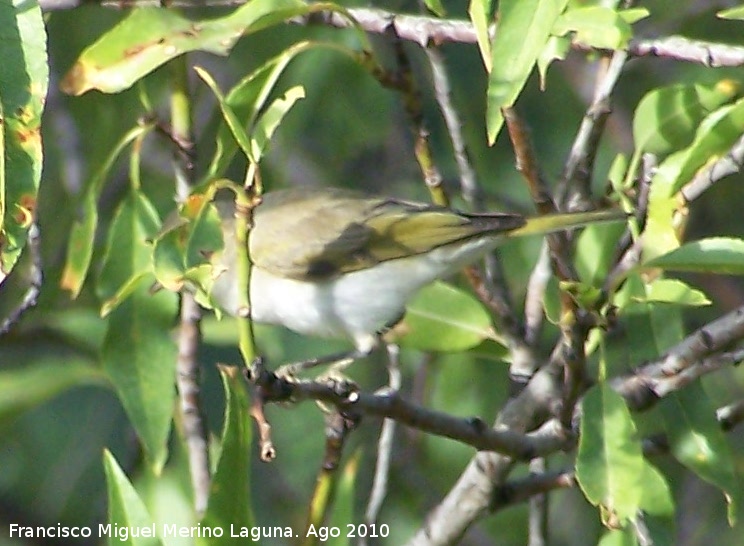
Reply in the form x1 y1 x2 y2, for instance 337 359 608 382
0 0 49 283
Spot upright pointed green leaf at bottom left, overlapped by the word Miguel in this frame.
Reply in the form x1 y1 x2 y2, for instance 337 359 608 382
102 449 163 546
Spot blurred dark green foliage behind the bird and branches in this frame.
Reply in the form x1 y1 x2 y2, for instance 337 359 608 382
0 0 744 545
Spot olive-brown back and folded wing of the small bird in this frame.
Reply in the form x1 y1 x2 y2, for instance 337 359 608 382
250 190 524 280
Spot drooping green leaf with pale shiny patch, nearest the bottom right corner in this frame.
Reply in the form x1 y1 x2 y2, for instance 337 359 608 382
660 383 742 525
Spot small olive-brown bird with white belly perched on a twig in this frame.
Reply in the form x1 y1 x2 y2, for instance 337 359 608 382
211 188 626 363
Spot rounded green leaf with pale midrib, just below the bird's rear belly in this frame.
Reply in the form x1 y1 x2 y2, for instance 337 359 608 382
395 282 495 352
